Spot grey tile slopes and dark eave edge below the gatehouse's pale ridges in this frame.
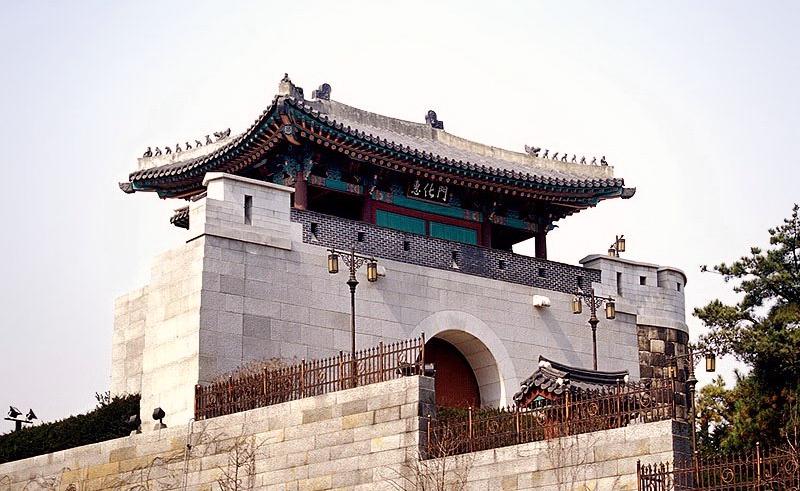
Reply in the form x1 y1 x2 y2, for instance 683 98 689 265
120 97 634 203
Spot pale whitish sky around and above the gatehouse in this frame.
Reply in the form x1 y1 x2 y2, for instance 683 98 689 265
0 0 800 432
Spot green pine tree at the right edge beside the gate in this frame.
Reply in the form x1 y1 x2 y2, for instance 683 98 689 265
694 205 800 451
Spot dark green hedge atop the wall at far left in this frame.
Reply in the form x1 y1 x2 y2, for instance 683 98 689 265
0 394 139 463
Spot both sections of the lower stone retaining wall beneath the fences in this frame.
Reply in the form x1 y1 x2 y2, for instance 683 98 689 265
0 377 675 491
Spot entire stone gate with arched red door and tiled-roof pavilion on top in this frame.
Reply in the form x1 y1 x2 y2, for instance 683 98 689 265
111 76 688 425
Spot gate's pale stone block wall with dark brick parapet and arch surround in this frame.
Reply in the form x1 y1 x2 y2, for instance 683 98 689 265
112 174 685 426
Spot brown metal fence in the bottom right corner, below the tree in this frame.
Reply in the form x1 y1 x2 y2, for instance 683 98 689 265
637 445 800 491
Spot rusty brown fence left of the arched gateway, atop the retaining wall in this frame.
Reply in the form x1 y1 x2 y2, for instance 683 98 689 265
194 336 425 420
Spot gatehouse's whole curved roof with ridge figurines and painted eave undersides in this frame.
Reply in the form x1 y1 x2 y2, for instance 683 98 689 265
119 75 632 223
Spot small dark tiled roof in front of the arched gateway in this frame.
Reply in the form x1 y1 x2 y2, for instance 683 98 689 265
514 356 628 405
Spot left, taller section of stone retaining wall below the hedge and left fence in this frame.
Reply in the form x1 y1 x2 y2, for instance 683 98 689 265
0 377 433 491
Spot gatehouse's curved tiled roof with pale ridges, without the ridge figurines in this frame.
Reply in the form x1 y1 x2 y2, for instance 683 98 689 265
120 78 634 198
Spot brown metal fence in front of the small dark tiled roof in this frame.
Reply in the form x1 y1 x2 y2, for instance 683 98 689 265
427 379 680 457
